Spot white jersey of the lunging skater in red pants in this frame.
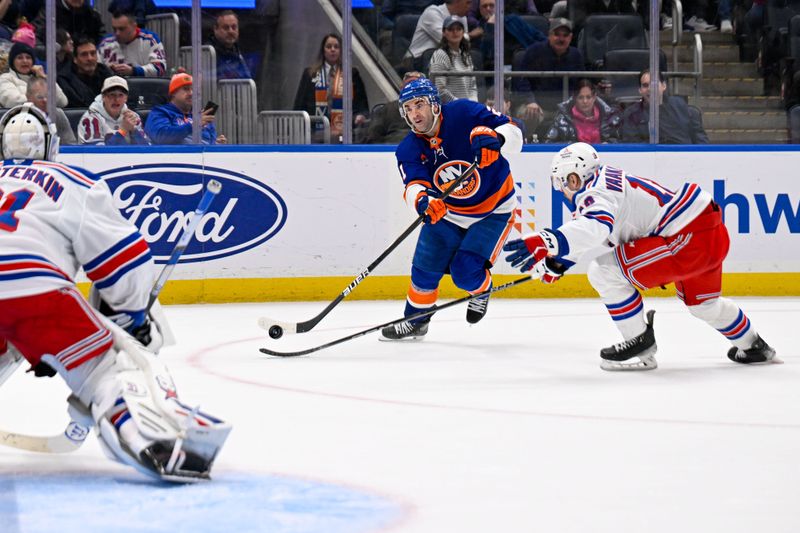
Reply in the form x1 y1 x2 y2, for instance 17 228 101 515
558 166 712 263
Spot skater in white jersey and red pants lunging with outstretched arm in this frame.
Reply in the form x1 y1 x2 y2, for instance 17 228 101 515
504 143 778 370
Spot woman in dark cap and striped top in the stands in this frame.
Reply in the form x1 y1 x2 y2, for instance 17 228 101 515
430 16 478 103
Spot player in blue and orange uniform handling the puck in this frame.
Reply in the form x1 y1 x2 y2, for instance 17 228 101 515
381 78 522 340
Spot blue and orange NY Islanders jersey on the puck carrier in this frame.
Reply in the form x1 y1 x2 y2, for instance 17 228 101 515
395 100 516 228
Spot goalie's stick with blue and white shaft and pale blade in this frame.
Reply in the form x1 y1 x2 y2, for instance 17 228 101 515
0 179 222 453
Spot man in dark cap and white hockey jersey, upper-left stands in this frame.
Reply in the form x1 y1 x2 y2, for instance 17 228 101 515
97 13 167 78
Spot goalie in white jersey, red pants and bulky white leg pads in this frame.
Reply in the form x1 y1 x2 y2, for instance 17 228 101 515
0 104 230 481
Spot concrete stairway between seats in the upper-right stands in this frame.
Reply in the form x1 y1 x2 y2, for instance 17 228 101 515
661 28 789 144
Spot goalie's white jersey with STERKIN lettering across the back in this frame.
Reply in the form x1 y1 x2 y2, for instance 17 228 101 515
0 160 155 313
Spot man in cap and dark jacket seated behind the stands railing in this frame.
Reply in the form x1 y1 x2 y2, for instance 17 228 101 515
512 18 585 136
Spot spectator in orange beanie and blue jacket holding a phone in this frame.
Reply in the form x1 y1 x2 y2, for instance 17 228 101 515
144 72 223 144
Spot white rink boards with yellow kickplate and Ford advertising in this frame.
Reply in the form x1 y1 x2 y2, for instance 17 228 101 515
60 145 800 303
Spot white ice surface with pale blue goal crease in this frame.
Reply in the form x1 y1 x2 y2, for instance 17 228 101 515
0 298 800 533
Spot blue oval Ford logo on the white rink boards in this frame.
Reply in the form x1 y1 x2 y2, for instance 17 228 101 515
99 164 287 263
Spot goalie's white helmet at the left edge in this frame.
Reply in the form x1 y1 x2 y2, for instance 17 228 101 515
0 102 59 161
